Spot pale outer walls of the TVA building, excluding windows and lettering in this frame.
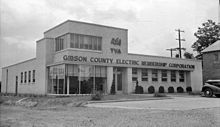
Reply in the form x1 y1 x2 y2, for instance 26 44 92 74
2 21 202 94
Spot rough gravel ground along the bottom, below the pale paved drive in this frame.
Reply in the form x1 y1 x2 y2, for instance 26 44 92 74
0 106 220 127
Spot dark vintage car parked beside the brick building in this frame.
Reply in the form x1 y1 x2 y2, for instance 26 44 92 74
202 79 220 97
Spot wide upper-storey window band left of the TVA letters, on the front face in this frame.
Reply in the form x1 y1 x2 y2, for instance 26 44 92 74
70 33 102 51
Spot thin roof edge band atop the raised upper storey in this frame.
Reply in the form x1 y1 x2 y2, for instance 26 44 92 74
44 20 128 33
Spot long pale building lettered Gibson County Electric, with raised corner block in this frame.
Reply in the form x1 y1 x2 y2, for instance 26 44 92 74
1 20 202 94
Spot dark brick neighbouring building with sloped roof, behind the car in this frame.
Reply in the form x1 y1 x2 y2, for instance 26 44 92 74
202 40 220 82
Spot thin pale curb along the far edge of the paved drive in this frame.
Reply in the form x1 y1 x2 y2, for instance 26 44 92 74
88 97 173 104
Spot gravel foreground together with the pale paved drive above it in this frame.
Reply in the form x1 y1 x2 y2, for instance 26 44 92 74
0 97 220 127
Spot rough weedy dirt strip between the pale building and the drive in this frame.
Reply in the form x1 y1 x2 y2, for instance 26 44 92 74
0 94 167 108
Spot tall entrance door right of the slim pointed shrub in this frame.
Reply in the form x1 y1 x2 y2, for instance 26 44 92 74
113 68 122 94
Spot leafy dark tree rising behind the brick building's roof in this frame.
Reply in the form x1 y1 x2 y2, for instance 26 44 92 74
192 20 220 59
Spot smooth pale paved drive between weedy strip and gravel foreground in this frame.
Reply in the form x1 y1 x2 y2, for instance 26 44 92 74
87 96 220 110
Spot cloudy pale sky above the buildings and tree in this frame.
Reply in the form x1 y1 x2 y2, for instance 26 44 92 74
0 0 219 80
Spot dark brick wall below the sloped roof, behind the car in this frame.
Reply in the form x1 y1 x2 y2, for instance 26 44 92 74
203 51 220 82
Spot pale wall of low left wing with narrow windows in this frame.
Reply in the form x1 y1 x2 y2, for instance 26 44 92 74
1 59 39 94
